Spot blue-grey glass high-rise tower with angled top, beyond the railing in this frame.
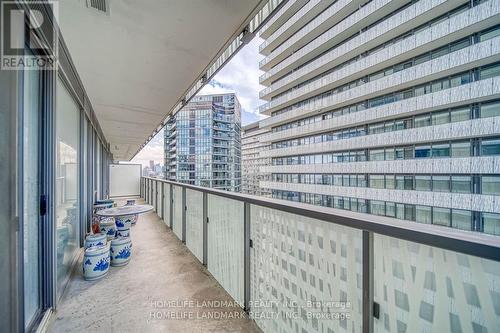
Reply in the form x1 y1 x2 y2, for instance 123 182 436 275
164 93 241 192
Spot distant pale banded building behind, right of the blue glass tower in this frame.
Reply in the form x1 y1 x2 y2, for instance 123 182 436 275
241 122 271 196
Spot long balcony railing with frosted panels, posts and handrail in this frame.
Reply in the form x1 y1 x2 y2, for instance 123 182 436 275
141 178 500 332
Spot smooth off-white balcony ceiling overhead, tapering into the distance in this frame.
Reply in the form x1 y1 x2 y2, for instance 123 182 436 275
59 0 260 160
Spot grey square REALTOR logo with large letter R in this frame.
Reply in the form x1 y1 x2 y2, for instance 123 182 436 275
0 1 59 70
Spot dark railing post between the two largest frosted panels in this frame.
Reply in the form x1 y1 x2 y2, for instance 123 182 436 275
362 230 373 333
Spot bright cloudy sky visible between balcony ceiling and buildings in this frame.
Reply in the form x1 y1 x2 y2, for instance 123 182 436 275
132 36 264 166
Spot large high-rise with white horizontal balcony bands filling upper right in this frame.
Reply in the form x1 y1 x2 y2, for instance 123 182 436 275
260 0 500 234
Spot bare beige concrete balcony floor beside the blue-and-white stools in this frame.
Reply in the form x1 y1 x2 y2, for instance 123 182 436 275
48 198 260 333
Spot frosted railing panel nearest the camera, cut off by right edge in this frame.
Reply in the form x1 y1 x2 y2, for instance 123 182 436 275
373 235 500 332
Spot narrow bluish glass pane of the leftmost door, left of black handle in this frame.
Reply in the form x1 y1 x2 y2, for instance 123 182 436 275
22 65 41 327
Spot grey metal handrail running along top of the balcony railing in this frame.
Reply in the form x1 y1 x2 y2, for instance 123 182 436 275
142 177 500 261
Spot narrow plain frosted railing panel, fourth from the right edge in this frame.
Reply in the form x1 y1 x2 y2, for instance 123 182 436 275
186 189 203 262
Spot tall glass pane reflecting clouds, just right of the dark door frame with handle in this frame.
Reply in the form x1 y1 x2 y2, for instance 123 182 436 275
55 78 80 296
